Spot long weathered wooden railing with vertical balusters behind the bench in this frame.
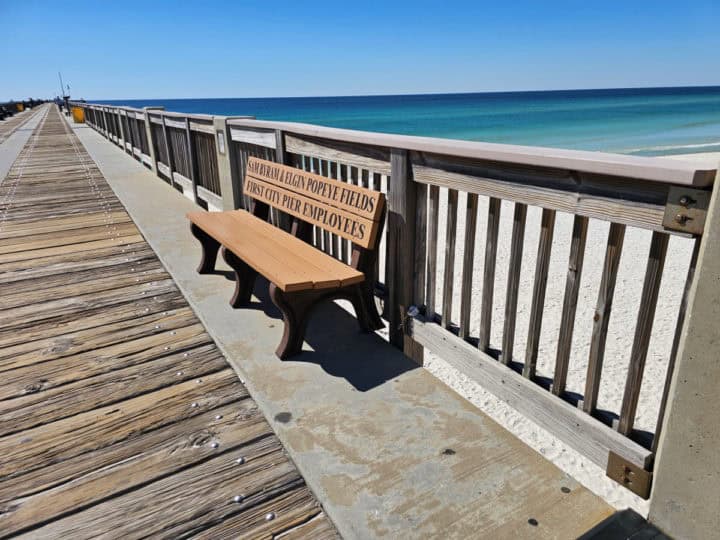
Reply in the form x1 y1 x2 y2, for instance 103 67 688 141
74 99 716 497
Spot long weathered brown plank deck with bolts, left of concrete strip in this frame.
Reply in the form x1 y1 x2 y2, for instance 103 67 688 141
0 106 337 539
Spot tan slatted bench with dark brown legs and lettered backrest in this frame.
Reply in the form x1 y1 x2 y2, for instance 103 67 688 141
187 157 385 359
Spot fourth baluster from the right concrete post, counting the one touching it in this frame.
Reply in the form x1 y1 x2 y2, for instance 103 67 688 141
550 216 590 396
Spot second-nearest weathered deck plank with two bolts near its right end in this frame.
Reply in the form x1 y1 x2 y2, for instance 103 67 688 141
20 437 303 539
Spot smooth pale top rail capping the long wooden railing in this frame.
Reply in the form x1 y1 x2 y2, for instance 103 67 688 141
67 102 718 187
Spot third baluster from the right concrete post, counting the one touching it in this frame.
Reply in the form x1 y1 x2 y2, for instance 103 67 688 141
582 223 625 414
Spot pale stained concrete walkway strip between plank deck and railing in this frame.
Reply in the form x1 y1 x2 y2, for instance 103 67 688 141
70 120 612 539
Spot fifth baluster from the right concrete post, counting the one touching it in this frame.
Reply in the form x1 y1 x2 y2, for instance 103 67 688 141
523 208 555 379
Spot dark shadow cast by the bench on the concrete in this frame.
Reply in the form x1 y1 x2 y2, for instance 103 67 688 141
224 270 420 392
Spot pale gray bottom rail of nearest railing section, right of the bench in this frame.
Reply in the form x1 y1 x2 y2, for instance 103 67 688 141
412 318 653 469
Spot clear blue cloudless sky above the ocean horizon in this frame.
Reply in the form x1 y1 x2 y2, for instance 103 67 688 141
0 0 720 100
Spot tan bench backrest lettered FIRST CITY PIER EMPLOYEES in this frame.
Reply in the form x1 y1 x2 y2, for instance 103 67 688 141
243 157 385 250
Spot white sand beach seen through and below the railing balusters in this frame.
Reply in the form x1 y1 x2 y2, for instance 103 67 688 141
368 153 720 515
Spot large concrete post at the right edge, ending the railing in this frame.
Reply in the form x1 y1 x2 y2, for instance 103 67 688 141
649 177 720 538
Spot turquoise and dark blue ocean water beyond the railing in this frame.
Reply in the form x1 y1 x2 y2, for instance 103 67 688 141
98 86 720 155
